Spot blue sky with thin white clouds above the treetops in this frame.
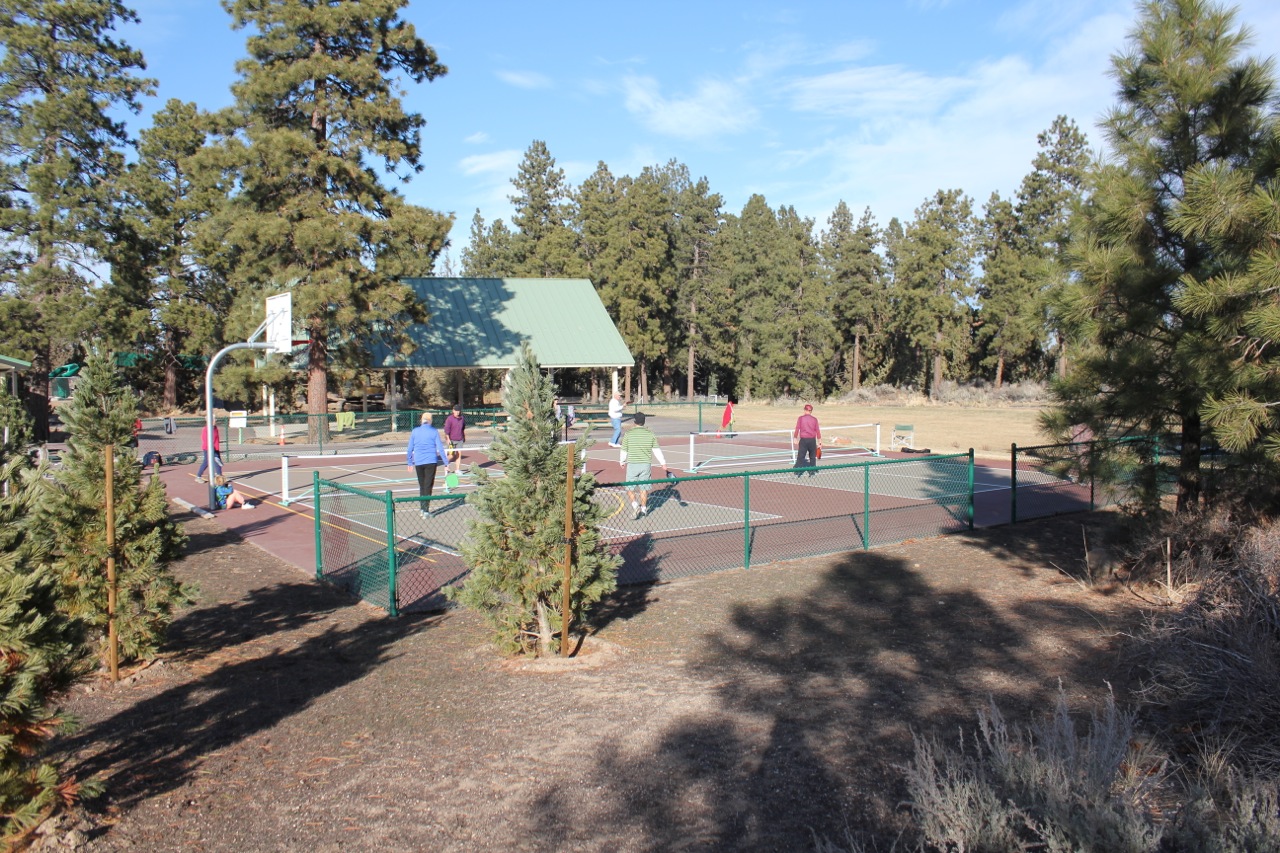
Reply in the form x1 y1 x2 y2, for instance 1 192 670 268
119 0 1280 263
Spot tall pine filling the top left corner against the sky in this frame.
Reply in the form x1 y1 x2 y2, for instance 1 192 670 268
0 0 152 384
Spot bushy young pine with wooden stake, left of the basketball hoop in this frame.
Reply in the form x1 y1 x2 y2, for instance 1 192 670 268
32 352 192 661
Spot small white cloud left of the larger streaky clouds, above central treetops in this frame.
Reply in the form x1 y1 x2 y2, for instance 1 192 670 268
622 76 759 140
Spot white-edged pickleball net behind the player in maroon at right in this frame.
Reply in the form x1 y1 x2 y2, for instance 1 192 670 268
685 424 881 473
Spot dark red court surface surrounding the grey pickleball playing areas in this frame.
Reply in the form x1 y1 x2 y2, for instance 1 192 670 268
149 437 1089 605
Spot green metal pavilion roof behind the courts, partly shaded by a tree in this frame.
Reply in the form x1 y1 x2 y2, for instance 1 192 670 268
370 278 635 369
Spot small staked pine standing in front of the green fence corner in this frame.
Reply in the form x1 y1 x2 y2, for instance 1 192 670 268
449 345 621 654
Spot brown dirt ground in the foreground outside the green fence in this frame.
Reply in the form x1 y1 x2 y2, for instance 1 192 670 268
42 502 1137 853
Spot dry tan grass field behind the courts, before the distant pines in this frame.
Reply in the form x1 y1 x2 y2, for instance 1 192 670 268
721 403 1051 459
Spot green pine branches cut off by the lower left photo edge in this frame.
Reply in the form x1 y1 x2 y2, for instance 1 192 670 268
0 446 90 844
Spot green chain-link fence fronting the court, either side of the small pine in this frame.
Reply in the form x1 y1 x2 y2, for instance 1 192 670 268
312 451 974 613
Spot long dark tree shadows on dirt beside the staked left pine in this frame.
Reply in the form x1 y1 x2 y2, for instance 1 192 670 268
58 581 442 808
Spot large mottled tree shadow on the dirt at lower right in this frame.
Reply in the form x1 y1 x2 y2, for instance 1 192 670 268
519 540 1131 850
